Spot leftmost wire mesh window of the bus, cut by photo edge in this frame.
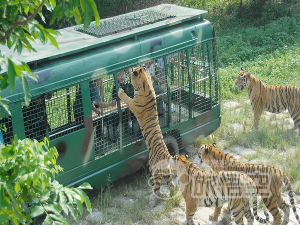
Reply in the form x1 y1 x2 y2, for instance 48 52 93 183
0 105 14 144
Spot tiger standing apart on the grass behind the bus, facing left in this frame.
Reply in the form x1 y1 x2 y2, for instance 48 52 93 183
235 68 300 129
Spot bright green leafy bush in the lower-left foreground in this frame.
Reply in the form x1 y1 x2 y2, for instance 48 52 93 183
0 138 91 224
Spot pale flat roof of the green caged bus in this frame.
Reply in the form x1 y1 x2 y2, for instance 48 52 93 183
0 4 207 64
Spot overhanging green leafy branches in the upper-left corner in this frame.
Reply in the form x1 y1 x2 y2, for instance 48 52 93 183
0 0 100 106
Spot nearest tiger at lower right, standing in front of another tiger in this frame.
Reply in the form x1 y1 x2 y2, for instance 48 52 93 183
170 155 269 225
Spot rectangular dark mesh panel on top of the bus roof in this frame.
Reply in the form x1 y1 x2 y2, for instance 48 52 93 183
75 9 175 37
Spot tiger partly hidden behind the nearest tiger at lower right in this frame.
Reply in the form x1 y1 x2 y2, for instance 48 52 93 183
198 143 300 225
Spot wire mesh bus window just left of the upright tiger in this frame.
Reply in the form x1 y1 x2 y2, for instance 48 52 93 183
90 72 142 158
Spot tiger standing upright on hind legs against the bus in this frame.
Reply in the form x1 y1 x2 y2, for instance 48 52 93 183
118 67 175 206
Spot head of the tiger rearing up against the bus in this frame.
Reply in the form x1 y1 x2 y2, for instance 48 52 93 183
131 67 152 91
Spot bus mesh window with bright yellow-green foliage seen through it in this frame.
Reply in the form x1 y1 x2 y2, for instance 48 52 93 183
45 85 84 140
